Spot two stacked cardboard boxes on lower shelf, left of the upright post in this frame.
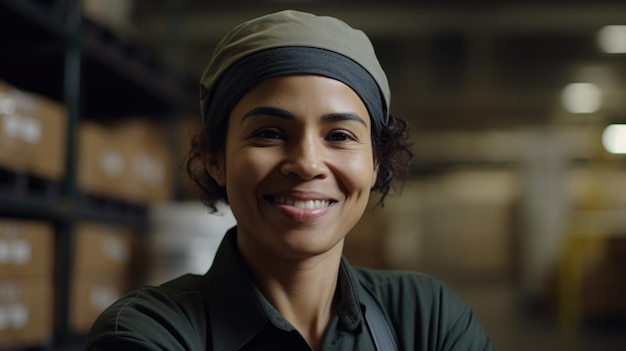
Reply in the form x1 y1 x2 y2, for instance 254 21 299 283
0 218 54 349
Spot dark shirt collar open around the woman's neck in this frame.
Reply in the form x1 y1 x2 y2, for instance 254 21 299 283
204 227 363 350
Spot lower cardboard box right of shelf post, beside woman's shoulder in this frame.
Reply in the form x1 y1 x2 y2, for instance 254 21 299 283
69 274 127 334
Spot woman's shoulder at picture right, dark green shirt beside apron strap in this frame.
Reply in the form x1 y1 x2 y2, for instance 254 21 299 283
354 268 493 351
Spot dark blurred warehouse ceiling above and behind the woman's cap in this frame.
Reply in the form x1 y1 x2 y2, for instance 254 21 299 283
128 0 626 129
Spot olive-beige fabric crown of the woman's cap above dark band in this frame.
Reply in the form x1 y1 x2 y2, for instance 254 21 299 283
200 10 391 121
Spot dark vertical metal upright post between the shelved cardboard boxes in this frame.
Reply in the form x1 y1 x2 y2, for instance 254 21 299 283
57 0 83 346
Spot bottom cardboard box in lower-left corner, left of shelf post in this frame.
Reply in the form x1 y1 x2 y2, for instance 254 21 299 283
0 278 54 348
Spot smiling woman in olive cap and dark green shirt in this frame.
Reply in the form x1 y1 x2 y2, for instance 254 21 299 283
86 11 493 350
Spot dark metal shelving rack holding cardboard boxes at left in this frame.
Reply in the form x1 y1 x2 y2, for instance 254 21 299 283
0 0 197 350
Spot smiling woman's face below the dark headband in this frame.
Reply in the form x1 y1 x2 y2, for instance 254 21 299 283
208 75 377 259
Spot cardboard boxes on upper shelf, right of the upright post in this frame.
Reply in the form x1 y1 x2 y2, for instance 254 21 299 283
77 118 172 205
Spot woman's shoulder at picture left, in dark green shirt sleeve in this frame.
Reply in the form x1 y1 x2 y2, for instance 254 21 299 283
86 275 206 350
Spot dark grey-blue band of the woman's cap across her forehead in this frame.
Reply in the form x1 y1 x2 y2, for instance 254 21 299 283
203 46 387 136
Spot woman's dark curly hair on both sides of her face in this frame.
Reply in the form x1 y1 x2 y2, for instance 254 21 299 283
185 111 413 212
